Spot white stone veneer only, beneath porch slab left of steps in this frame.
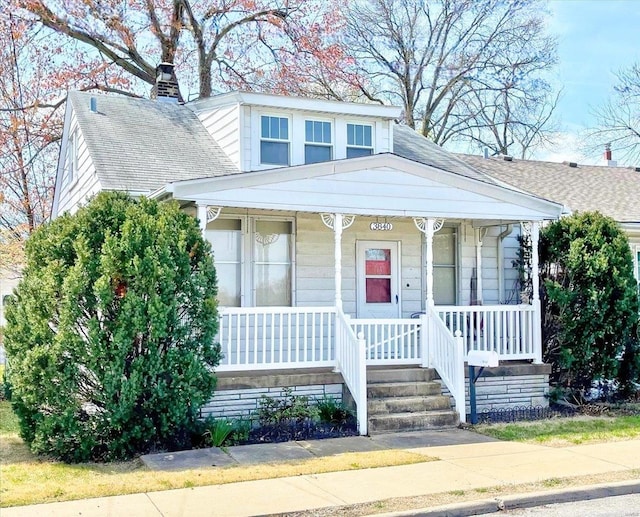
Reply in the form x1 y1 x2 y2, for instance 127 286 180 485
200 384 343 419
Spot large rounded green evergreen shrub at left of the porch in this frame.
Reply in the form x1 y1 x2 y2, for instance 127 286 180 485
5 193 220 461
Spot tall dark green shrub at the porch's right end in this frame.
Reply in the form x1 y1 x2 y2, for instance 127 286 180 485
540 212 638 395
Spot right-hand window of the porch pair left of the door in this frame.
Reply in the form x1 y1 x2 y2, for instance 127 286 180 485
253 220 293 307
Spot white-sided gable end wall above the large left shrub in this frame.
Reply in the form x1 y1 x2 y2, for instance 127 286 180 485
53 109 101 217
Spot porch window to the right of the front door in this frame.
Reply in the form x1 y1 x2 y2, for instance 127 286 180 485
433 226 457 305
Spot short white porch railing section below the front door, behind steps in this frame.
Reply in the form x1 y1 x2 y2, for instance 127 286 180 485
351 319 421 365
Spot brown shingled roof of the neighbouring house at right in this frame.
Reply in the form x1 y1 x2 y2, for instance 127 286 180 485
457 154 640 223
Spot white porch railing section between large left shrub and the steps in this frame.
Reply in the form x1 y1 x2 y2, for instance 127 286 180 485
217 307 336 372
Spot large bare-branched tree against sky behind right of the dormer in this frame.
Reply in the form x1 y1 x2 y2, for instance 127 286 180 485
347 0 556 152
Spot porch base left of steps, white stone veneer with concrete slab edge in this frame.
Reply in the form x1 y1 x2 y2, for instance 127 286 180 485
200 371 343 419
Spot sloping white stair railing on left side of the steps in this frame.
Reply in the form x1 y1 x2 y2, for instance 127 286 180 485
335 309 367 436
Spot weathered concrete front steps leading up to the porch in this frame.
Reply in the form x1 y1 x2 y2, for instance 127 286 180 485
367 368 459 434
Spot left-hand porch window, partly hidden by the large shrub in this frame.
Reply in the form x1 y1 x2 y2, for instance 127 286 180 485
205 219 242 307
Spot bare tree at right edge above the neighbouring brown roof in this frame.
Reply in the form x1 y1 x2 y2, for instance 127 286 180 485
584 63 640 165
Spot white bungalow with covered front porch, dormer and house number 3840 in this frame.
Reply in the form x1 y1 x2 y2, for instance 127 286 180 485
53 66 562 434
